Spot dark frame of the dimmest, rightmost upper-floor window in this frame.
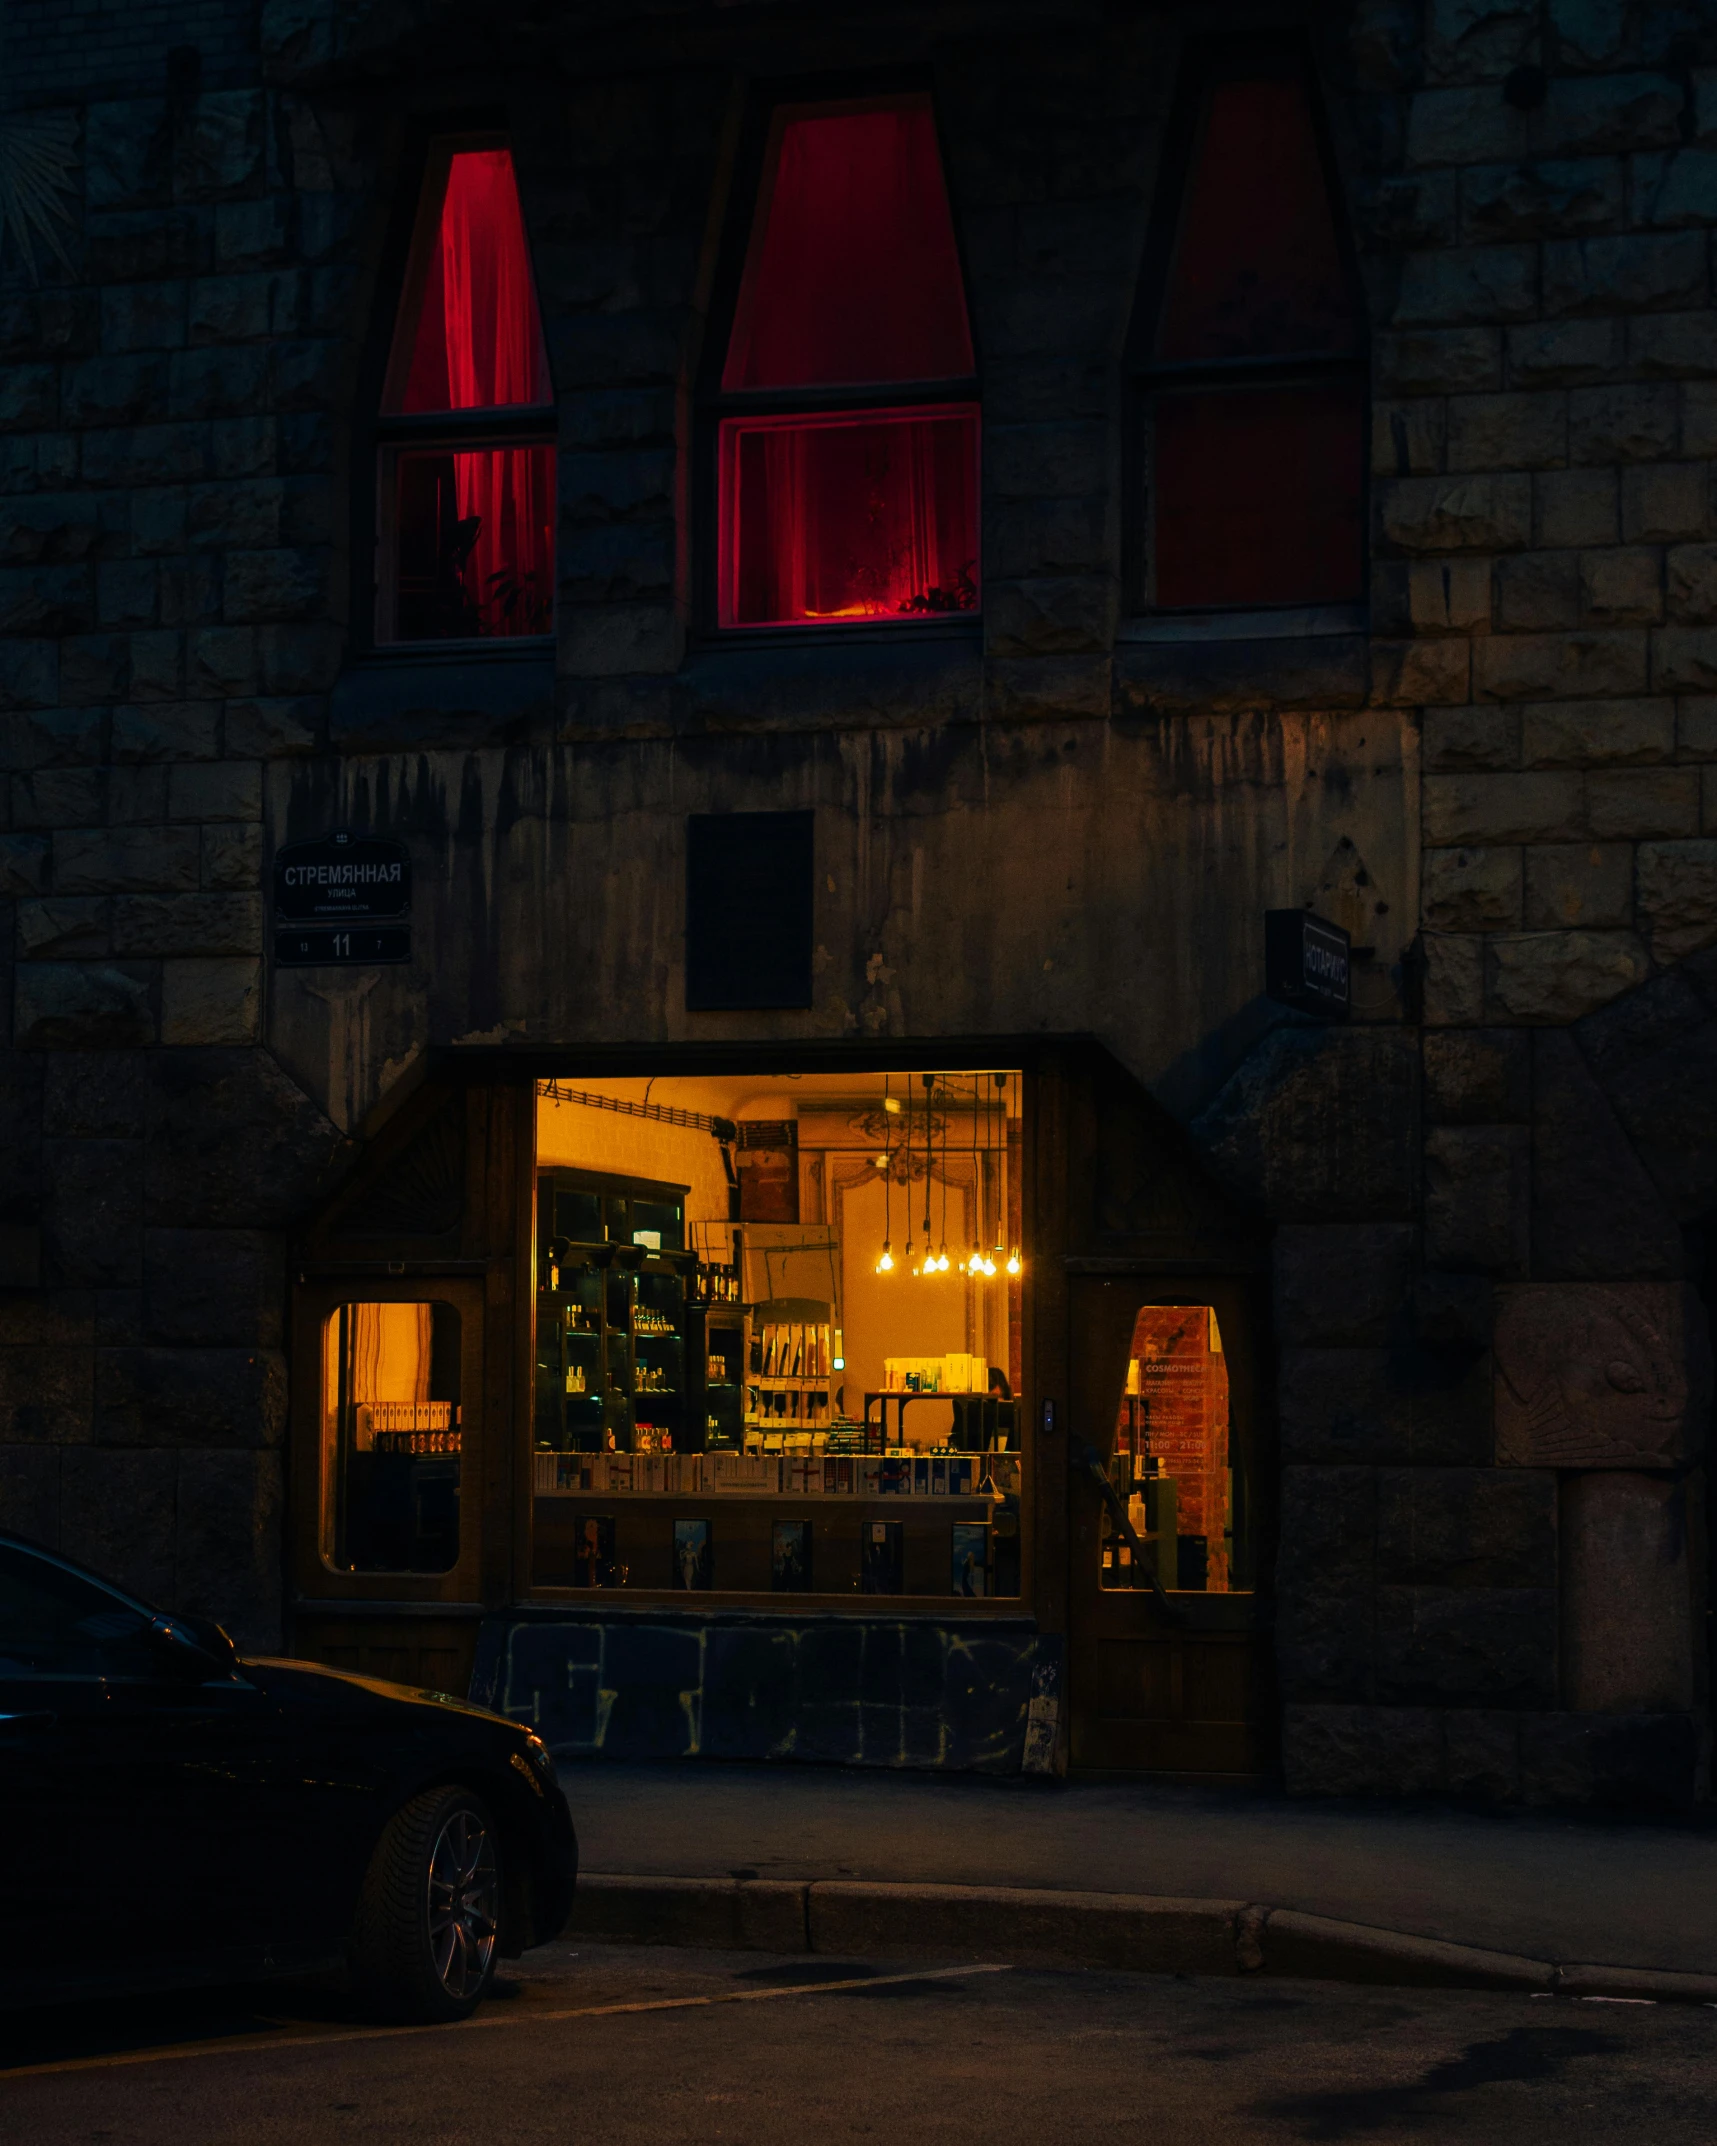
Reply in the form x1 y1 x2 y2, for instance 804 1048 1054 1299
1120 36 1371 631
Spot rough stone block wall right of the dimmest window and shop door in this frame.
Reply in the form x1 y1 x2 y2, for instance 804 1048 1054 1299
1277 0 1717 1798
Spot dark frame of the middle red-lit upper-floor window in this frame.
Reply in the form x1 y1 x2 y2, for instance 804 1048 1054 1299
691 71 983 648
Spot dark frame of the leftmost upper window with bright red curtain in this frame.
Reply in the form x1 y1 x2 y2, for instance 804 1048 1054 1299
364 122 560 661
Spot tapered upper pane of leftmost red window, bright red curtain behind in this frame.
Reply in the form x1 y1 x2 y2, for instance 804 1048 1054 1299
386 148 552 410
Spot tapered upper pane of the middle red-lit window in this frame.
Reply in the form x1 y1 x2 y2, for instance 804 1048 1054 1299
721 99 972 388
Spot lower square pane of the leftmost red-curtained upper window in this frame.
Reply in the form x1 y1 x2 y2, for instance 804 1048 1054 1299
393 446 554 642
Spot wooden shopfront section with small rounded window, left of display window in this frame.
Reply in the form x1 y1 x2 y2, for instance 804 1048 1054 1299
290 1075 534 1691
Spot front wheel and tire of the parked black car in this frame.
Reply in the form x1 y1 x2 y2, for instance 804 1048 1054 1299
350 1788 504 2022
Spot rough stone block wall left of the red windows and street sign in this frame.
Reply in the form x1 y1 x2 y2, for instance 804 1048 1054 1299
0 41 337 1644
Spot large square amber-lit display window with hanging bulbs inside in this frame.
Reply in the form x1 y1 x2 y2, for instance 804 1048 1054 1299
532 1071 1026 1601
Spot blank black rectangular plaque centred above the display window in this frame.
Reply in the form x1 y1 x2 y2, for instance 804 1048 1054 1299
685 811 813 1013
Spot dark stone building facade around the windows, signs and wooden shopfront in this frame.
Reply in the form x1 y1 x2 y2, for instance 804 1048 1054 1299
0 0 1717 1803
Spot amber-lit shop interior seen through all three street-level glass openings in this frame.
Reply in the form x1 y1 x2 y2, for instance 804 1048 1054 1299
311 1069 1251 1599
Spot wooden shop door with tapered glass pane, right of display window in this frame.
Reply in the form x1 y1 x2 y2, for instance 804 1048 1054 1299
1069 1273 1264 1779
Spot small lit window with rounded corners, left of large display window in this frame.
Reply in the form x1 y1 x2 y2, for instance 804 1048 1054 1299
322 1300 466 1573
